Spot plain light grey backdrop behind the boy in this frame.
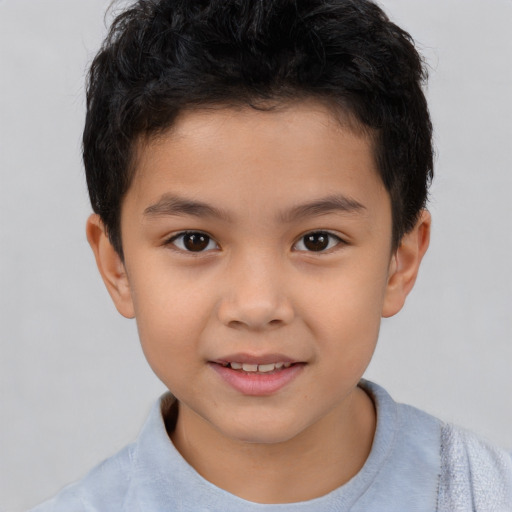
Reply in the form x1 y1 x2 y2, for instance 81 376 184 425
0 0 512 511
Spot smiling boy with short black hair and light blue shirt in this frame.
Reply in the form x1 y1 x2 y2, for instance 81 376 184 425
31 0 512 511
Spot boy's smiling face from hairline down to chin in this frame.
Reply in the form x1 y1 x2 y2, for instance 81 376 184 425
89 102 428 443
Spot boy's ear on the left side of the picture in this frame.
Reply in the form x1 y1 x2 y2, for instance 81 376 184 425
86 214 135 318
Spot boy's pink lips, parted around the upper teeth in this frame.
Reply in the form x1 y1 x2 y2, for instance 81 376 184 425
209 354 306 396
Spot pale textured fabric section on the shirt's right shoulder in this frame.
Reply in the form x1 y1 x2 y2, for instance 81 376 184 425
439 424 512 512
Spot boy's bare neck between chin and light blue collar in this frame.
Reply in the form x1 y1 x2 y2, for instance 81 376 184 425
171 388 376 503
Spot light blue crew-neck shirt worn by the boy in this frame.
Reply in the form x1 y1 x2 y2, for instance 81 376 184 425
32 381 512 512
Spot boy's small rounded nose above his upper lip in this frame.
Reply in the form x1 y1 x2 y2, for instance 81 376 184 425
218 250 295 331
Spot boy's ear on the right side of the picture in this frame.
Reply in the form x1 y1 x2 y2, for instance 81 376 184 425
382 210 431 318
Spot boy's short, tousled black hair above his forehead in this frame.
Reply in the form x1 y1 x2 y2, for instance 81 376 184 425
83 0 433 257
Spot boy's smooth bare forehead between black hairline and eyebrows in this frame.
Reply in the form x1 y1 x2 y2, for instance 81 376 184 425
127 101 387 222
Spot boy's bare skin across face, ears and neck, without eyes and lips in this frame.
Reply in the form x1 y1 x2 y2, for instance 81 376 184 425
87 101 430 503
